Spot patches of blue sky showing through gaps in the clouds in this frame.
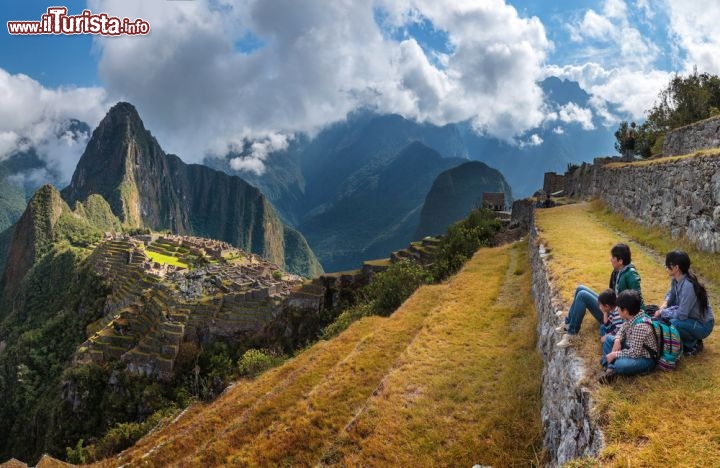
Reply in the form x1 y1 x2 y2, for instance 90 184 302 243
0 0 673 87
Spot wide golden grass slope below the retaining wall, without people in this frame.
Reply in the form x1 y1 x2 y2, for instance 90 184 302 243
97 242 541 466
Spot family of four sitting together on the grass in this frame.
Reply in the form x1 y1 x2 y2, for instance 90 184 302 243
555 244 715 383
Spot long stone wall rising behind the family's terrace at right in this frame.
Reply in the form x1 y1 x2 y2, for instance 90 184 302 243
565 155 720 252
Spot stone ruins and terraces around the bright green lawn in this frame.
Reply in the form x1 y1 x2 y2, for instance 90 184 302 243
76 234 301 378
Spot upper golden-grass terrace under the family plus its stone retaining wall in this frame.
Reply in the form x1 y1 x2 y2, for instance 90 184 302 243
530 203 720 466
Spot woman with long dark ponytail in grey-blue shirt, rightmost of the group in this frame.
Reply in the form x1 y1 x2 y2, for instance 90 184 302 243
655 250 715 355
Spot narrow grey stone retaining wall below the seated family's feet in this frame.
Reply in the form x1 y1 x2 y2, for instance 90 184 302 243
529 229 603 466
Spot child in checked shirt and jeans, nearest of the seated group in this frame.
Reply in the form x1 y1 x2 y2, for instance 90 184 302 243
599 289 658 384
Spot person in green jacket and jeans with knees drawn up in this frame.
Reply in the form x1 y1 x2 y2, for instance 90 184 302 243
555 244 644 348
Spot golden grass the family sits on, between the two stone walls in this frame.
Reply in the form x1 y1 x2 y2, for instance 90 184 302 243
536 202 720 466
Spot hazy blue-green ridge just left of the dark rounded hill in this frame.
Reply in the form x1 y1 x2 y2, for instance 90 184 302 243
299 142 469 271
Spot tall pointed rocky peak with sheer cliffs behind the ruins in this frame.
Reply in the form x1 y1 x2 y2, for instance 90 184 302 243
62 103 322 276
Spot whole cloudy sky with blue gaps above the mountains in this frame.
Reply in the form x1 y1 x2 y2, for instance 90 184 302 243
0 0 720 170
